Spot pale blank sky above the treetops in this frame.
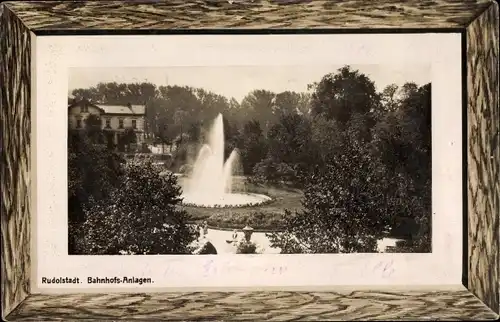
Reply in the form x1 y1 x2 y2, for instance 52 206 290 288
68 64 431 102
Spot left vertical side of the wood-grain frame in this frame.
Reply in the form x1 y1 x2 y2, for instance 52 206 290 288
0 2 31 320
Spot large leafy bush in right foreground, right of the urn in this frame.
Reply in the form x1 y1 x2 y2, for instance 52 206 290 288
270 134 391 253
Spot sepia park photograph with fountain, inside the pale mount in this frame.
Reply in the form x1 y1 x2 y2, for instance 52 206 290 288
67 63 432 255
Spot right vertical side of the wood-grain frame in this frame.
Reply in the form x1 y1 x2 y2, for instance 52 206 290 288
467 3 500 312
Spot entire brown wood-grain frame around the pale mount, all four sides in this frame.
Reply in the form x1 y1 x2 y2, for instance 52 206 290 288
0 0 500 321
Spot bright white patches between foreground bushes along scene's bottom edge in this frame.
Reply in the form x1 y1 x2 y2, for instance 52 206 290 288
191 228 399 254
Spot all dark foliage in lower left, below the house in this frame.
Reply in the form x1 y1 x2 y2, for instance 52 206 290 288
68 127 195 255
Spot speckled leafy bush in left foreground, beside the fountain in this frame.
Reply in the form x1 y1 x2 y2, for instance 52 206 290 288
78 160 196 255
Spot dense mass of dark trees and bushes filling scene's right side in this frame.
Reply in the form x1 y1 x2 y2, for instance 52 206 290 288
270 68 432 253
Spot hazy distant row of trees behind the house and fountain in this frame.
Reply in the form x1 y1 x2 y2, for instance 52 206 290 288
70 82 310 143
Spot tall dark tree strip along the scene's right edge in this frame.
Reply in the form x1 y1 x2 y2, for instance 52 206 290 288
373 83 432 251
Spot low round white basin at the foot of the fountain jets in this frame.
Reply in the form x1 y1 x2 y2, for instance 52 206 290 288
182 193 272 208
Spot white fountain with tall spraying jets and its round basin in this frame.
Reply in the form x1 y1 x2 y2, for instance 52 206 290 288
182 114 271 208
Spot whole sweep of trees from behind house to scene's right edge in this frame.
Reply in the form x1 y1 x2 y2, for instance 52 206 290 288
72 66 431 252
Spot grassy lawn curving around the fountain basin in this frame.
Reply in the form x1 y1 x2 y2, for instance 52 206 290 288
182 182 303 231
